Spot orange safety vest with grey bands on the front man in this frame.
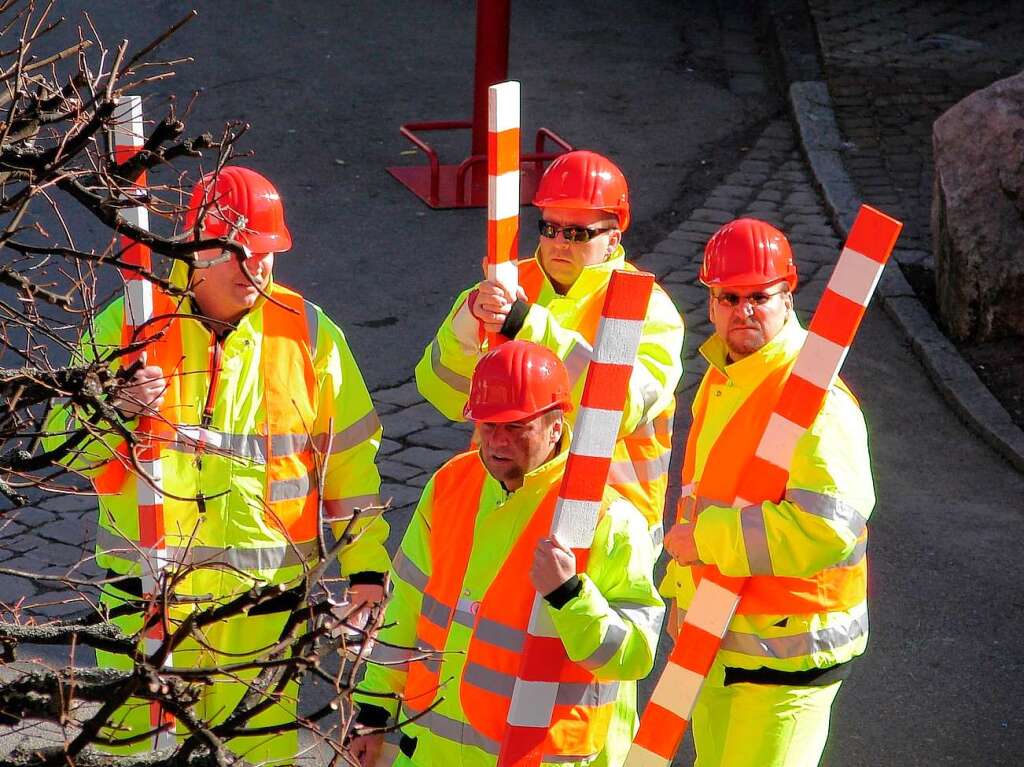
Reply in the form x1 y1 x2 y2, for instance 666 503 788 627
404 452 618 760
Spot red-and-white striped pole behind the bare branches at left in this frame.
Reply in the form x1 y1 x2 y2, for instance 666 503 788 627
111 96 174 749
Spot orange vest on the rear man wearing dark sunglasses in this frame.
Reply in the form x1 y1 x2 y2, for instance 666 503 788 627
519 258 676 528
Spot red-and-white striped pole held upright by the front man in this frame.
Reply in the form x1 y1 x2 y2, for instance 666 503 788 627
498 271 654 767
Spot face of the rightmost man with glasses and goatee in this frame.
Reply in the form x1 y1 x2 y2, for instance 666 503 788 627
709 283 793 361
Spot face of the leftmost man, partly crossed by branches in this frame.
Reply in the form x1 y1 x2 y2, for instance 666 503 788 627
191 250 273 323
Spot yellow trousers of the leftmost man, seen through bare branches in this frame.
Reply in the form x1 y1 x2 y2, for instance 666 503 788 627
96 585 299 765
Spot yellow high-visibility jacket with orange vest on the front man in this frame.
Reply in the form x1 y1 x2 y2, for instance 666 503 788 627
356 439 664 767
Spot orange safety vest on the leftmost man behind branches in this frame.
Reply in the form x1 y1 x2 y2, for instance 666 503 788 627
93 284 318 544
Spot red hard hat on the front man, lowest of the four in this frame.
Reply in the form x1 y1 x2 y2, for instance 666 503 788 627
463 341 572 423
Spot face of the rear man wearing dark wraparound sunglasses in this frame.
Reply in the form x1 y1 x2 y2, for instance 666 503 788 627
540 208 622 292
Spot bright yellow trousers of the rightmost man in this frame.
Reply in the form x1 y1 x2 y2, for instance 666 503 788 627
692 664 842 767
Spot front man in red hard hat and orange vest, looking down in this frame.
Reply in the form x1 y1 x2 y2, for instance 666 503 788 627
351 341 663 767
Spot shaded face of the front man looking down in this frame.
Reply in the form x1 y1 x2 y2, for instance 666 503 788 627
477 410 562 491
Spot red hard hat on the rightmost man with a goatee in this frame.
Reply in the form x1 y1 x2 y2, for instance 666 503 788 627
699 218 797 290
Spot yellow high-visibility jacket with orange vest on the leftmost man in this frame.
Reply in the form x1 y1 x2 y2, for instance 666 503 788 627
40 269 389 595
